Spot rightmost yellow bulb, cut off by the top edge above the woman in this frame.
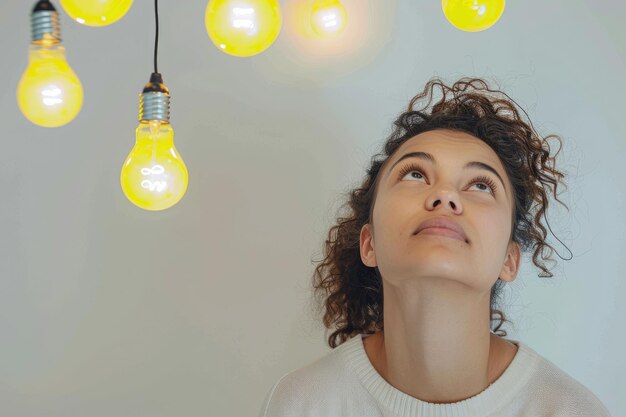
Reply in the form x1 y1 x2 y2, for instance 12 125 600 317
441 0 505 32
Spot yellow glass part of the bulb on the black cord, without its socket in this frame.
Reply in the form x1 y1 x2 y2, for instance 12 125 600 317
120 120 189 211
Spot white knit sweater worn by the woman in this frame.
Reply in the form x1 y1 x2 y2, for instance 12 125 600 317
259 334 610 417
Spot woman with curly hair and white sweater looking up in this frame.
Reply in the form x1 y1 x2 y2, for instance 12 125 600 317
260 78 609 417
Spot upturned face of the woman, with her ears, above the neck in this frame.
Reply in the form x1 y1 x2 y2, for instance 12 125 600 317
361 129 519 293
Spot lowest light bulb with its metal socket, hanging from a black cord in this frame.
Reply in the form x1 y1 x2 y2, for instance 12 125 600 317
120 73 189 211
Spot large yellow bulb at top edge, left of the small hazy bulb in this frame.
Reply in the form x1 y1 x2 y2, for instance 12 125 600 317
204 0 282 57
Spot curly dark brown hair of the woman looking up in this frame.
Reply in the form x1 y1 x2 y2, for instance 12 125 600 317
313 77 569 348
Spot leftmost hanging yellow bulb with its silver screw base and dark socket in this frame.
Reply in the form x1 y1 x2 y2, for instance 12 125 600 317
16 0 83 127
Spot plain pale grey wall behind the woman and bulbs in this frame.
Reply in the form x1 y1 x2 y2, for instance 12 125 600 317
0 0 626 417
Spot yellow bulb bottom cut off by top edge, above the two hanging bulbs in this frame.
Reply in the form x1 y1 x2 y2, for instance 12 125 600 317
61 0 133 26
